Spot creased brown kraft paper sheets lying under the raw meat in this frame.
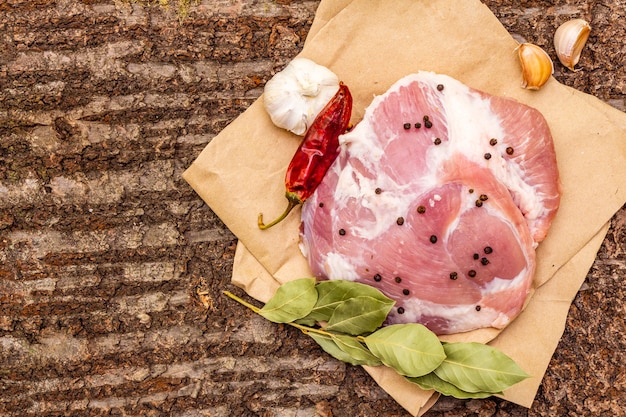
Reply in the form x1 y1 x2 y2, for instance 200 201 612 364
183 0 626 415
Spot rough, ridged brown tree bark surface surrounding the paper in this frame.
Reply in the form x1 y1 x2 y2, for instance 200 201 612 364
0 0 626 417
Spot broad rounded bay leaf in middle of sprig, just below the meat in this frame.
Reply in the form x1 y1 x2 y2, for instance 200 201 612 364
364 323 446 377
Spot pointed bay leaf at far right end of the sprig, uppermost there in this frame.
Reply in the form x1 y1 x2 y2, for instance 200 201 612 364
434 342 529 393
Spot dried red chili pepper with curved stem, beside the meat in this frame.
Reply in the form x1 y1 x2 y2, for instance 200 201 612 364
258 83 352 229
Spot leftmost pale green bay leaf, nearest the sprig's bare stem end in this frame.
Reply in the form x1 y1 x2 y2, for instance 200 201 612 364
259 278 317 323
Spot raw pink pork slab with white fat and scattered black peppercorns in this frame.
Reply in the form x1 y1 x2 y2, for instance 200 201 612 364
301 72 560 334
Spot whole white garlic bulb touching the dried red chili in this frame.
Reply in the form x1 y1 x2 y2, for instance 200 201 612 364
263 58 339 135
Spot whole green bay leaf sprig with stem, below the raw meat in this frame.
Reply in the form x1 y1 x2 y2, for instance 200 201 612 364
224 278 529 399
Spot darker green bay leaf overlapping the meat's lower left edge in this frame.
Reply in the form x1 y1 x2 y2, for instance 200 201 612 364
324 295 394 336
